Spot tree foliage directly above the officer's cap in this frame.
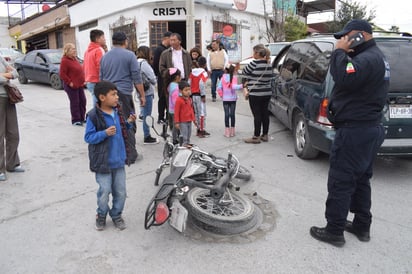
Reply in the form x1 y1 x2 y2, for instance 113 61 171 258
327 0 376 33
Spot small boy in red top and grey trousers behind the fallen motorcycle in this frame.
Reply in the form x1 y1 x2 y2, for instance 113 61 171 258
174 81 196 146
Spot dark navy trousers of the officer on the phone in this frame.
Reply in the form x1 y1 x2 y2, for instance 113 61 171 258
325 125 384 235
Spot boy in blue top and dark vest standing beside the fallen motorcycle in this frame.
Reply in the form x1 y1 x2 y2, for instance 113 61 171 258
84 81 136 230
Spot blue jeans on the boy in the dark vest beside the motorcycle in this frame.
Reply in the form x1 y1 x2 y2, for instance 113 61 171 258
96 167 126 219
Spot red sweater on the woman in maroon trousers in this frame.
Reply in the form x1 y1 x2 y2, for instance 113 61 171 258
59 56 84 88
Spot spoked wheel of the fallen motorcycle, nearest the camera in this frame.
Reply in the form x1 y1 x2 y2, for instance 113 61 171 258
186 188 258 234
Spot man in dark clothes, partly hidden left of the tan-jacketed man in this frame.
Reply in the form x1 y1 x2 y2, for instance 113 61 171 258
152 31 172 123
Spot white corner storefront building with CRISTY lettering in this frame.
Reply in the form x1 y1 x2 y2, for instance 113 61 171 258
69 0 284 62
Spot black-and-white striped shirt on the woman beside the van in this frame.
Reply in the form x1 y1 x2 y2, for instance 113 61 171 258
242 60 273 96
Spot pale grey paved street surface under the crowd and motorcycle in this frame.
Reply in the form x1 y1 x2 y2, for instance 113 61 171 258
0 81 412 274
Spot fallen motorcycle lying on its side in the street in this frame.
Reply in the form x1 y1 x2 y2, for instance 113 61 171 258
144 116 258 234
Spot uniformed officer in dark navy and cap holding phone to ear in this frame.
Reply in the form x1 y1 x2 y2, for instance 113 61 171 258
310 19 390 246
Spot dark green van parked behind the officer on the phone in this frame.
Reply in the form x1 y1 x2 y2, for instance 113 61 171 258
269 34 412 159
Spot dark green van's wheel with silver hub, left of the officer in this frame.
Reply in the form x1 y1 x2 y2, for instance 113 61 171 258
293 113 319 159
